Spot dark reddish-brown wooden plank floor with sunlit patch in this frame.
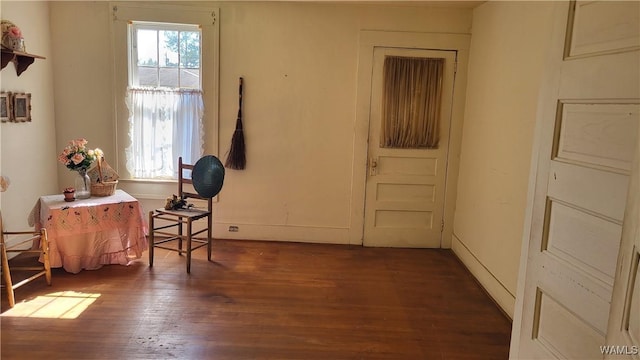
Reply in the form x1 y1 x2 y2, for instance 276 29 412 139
0 240 511 360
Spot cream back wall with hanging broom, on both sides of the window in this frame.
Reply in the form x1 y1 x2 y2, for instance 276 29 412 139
51 2 471 243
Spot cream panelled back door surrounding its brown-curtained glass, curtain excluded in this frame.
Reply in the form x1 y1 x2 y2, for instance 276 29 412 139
363 47 456 248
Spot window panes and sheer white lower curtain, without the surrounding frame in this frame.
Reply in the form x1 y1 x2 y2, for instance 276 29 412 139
125 22 204 179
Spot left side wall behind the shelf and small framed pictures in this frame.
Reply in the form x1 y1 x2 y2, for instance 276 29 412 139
0 0 60 230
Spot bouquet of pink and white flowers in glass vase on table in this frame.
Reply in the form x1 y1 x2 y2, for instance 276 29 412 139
58 139 103 199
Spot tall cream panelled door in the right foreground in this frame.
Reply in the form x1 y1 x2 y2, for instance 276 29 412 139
511 1 640 359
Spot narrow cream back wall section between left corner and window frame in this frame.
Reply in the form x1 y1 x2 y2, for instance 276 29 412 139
50 1 115 193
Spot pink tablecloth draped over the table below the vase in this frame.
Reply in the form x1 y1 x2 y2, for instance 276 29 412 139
29 190 148 273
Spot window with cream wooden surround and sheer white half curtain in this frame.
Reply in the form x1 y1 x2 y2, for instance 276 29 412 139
110 1 220 186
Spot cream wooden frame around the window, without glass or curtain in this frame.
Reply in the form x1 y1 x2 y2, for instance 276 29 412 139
110 2 220 188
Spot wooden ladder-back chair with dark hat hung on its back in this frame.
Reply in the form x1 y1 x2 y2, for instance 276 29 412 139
149 156 224 273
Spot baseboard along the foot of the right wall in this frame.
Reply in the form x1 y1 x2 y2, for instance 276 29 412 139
451 234 516 320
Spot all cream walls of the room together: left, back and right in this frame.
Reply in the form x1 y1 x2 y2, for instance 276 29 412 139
0 0 564 315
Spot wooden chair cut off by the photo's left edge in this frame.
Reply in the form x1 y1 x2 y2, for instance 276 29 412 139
0 210 51 307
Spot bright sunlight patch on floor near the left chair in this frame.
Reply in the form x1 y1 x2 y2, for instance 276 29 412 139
1 291 100 319
